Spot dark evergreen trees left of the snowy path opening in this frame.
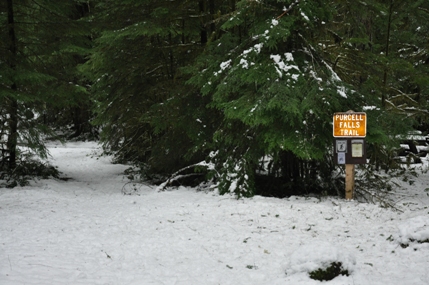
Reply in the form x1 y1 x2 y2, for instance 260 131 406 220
0 0 88 175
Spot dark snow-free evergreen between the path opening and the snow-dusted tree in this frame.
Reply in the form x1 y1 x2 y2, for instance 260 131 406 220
85 0 221 173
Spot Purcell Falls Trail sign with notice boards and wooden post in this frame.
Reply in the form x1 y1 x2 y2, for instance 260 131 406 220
333 111 366 200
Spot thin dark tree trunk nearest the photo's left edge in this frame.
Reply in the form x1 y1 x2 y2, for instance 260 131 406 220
7 0 18 169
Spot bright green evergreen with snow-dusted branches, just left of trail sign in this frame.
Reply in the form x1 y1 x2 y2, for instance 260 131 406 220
189 1 364 196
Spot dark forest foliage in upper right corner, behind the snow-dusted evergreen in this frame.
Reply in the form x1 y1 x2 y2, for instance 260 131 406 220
322 0 429 124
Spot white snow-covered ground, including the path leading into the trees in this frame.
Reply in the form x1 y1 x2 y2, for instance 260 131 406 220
0 143 429 285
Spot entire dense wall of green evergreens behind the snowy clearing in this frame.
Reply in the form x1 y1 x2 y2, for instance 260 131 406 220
0 0 429 196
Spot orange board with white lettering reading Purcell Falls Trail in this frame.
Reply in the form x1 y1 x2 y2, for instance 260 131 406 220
333 112 366 138
